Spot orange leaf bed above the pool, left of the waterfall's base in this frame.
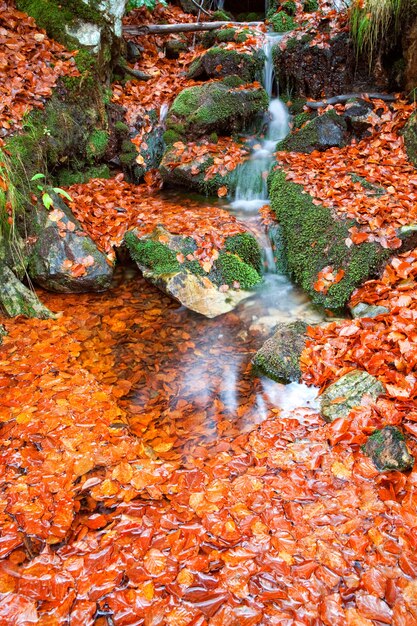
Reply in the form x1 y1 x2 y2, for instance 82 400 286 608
68 174 247 263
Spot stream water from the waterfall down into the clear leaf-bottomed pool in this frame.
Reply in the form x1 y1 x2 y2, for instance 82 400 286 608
118 35 322 459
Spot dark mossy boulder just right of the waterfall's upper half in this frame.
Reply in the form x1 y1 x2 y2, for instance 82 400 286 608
277 110 348 154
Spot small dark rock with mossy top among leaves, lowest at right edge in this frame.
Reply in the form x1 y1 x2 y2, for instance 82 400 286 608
362 426 414 472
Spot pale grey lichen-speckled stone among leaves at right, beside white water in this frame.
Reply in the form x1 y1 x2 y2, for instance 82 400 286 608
320 370 385 422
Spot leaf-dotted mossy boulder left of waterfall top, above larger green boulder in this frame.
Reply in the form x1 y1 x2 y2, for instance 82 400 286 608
188 46 265 83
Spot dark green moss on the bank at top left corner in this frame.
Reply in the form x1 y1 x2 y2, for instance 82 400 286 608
16 0 104 49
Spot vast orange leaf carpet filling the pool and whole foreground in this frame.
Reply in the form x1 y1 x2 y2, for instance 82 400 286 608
0 277 417 626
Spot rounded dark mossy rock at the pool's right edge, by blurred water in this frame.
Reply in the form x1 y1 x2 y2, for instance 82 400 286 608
252 321 307 383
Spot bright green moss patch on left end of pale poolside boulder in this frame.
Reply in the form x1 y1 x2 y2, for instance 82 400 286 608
125 232 181 276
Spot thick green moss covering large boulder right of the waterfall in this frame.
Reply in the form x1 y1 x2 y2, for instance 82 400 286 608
269 169 390 310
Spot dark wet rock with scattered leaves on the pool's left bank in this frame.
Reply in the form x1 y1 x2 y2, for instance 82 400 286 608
28 193 113 293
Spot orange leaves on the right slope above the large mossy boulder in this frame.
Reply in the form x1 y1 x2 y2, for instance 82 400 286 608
277 101 417 249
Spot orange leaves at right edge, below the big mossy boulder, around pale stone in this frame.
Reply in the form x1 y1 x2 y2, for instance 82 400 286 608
302 250 417 444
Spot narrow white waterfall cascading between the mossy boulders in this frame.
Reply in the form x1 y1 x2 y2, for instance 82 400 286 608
232 33 289 212
